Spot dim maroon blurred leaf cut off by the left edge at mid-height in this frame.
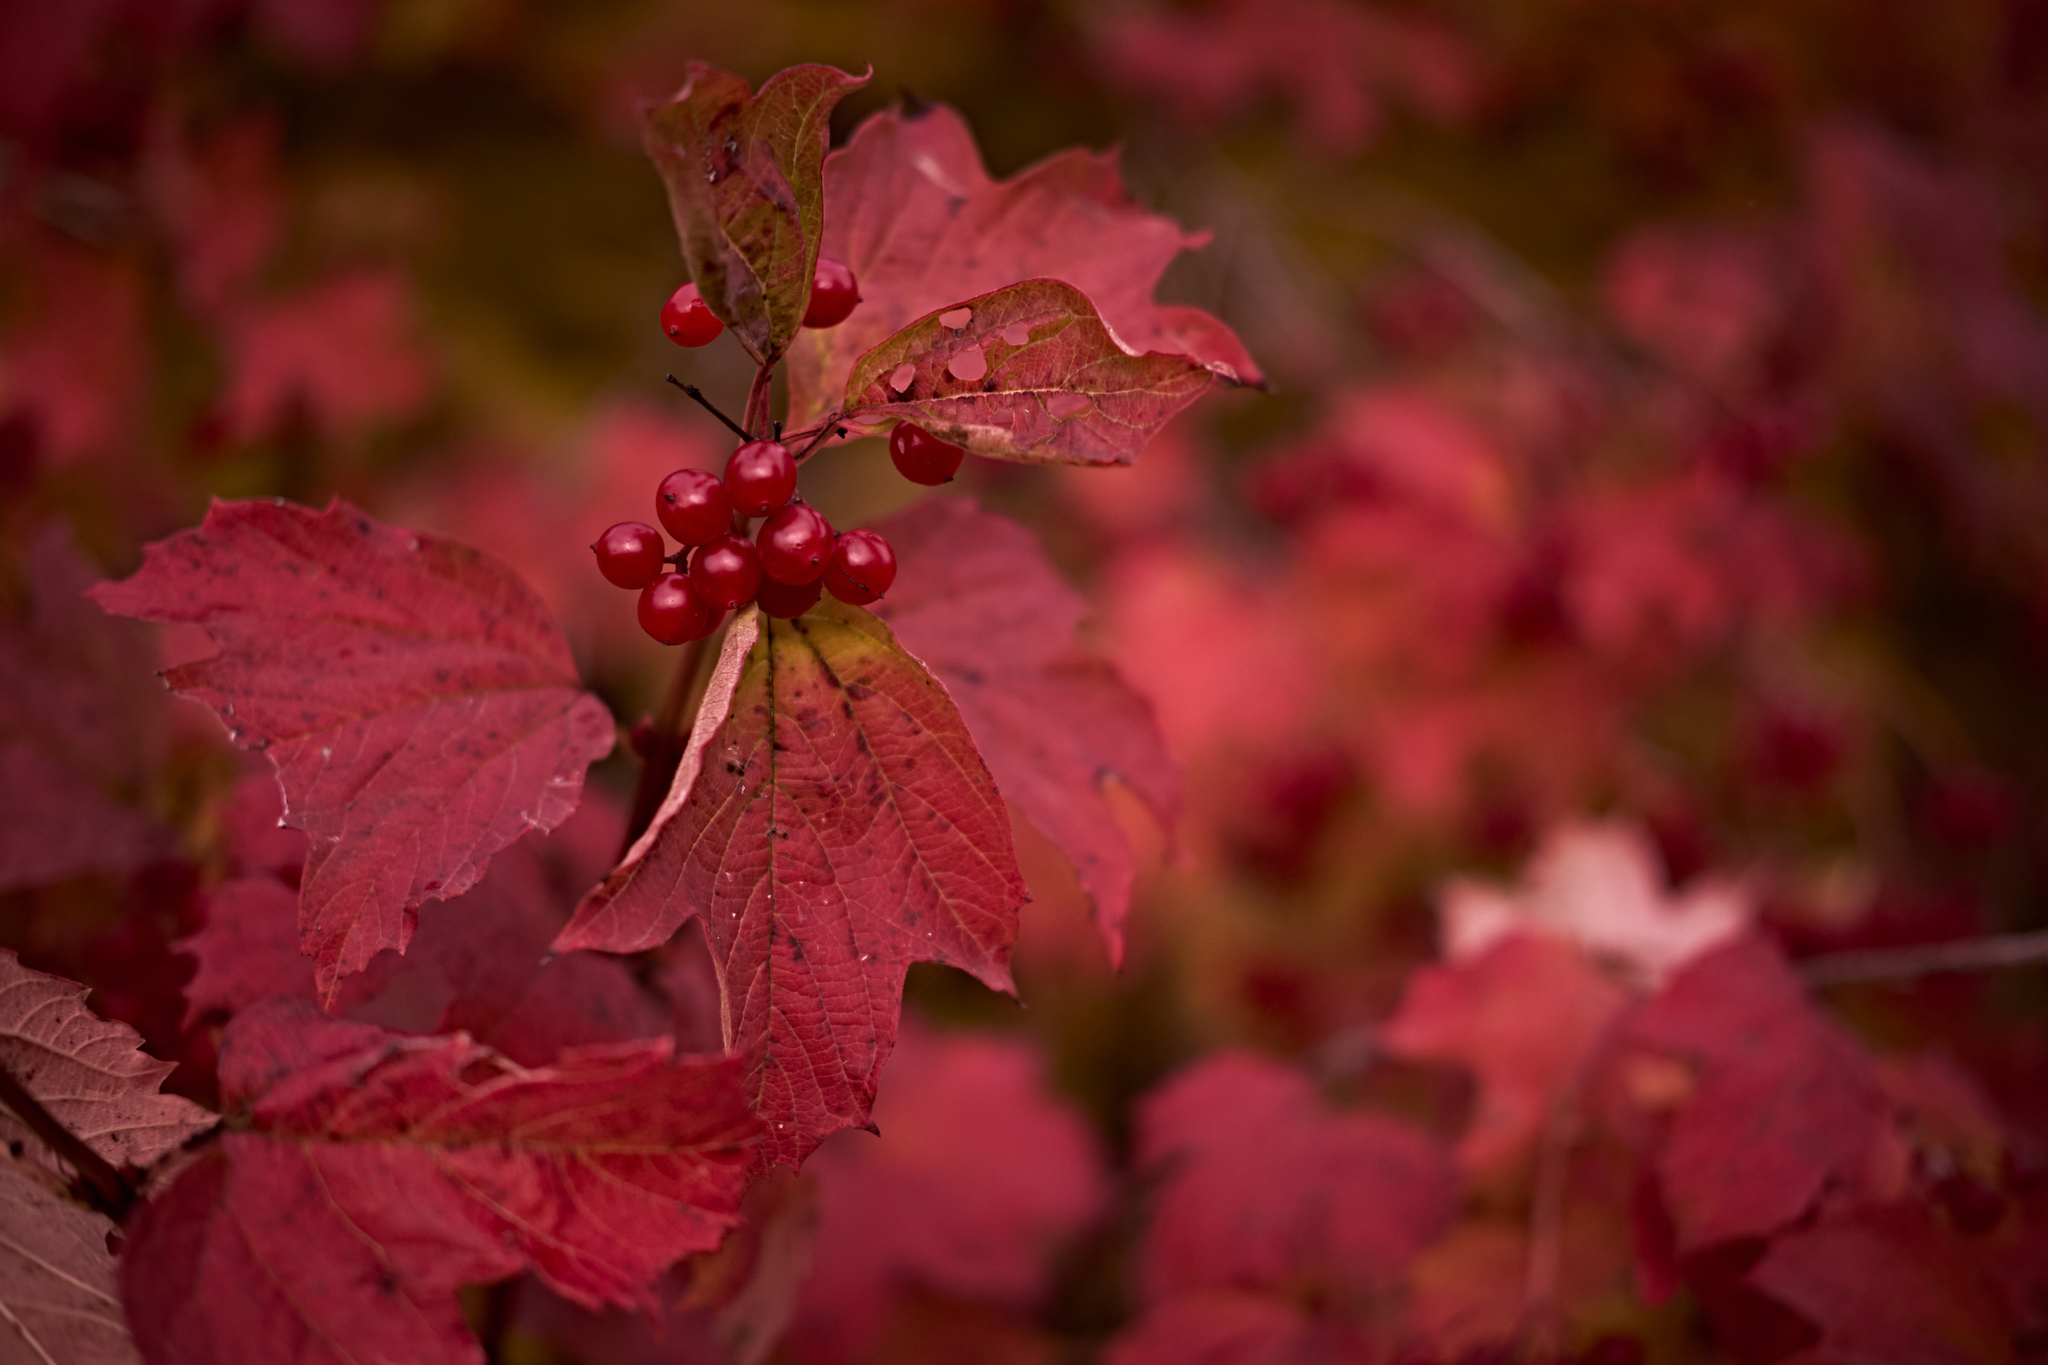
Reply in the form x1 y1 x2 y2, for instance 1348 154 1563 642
0 524 172 888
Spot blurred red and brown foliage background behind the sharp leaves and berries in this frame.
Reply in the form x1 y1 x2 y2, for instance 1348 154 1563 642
0 0 2048 1365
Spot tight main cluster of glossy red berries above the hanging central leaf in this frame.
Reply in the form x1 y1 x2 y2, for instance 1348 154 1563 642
590 440 895 645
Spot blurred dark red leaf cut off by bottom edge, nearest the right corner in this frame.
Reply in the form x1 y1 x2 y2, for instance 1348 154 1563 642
1749 1205 2023 1365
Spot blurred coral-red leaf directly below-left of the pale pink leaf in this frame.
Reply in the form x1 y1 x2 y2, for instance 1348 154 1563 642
1382 931 1628 1171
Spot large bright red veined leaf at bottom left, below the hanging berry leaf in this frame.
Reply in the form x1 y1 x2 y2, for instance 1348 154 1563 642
121 1001 758 1363
